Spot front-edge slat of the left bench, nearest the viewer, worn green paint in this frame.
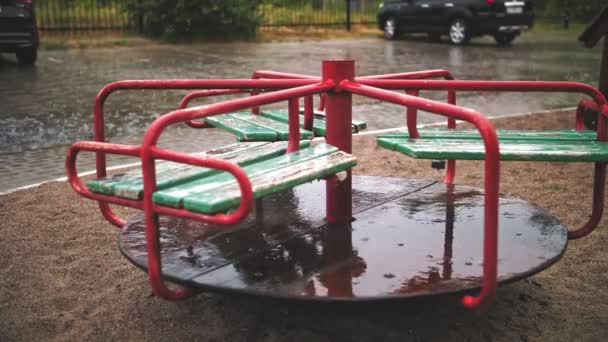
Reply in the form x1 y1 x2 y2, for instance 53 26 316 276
184 151 357 213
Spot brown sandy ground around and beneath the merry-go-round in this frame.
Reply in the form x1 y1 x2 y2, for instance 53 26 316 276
0 113 608 341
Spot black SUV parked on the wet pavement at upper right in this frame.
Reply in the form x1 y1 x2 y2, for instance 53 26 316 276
378 0 534 45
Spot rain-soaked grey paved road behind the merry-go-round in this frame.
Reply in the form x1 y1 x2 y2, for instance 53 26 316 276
0 33 599 192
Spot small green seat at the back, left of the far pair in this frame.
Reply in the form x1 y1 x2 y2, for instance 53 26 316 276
205 112 313 141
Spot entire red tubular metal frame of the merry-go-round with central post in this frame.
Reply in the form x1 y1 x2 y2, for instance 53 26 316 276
66 60 608 307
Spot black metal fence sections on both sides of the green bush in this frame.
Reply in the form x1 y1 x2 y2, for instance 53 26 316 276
35 0 382 32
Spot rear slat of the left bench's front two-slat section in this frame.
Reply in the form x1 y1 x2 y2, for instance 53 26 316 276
153 144 346 207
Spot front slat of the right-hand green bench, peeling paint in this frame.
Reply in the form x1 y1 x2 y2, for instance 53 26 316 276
378 138 608 162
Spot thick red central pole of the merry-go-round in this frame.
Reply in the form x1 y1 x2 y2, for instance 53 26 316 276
323 60 355 224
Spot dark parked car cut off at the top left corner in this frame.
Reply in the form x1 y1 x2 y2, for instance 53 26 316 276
0 0 39 65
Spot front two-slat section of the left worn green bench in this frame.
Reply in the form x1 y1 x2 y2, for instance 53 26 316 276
153 143 356 213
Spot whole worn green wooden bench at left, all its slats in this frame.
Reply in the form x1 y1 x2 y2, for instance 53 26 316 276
87 141 357 214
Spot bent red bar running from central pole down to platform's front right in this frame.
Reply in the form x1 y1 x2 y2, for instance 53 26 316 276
340 81 500 307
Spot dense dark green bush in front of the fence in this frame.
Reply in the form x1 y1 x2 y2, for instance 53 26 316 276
125 0 261 41
